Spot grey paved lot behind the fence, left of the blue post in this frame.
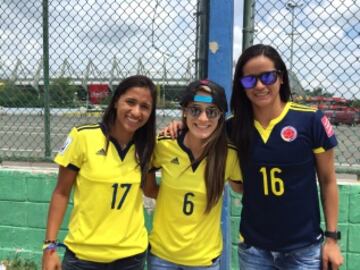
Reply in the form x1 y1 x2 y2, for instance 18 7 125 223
0 110 180 160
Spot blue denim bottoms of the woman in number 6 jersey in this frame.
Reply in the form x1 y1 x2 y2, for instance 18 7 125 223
147 253 220 270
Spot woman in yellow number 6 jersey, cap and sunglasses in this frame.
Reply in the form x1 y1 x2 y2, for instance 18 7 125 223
144 80 241 270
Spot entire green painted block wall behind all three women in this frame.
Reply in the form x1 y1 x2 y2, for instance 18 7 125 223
0 169 360 270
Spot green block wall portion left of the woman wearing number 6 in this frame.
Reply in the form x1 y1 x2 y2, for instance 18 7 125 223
0 169 156 265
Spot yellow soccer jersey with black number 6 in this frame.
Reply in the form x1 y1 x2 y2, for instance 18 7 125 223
149 132 242 266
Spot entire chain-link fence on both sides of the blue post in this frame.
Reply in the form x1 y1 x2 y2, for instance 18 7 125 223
0 0 360 170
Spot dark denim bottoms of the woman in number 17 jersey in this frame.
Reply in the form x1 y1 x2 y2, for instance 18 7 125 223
62 249 146 270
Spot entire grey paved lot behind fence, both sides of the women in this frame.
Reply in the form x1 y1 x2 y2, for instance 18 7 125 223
0 110 360 166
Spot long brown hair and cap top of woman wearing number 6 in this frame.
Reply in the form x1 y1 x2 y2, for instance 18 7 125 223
181 80 228 213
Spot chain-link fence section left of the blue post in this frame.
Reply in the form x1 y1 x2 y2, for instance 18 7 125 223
0 0 208 160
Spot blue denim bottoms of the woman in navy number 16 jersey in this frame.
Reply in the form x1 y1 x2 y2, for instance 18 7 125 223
239 241 322 270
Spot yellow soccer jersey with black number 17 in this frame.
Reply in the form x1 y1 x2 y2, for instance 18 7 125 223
55 125 148 262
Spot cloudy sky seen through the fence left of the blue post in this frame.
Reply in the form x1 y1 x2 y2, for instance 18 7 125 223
0 0 197 78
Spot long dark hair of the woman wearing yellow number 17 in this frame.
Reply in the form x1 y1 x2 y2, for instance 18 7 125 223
102 75 156 186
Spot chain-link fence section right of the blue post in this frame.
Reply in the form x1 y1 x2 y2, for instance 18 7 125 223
243 0 360 172
